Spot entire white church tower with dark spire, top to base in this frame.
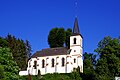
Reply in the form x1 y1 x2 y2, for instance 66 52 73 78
70 18 83 72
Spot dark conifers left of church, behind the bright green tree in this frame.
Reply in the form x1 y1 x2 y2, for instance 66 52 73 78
6 34 31 70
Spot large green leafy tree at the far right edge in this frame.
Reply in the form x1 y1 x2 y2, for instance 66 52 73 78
95 36 120 80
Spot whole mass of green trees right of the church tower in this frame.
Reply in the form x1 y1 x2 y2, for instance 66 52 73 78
83 36 120 80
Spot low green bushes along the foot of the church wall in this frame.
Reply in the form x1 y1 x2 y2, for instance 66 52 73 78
32 67 82 80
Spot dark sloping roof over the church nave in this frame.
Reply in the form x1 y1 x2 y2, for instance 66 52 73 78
31 47 71 58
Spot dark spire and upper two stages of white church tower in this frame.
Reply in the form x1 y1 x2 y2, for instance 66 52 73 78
70 18 83 56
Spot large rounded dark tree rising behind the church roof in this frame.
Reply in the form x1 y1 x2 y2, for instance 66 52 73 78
48 28 65 48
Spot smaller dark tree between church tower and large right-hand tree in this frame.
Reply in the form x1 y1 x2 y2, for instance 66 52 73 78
83 52 96 80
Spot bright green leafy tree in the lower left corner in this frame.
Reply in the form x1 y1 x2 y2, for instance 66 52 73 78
0 48 19 80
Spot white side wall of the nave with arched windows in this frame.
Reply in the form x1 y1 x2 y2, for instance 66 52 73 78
27 55 72 75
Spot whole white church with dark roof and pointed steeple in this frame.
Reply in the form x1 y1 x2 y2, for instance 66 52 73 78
19 18 83 76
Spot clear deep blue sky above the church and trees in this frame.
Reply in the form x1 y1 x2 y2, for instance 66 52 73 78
0 0 120 53
